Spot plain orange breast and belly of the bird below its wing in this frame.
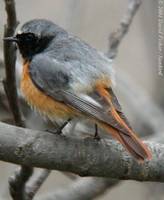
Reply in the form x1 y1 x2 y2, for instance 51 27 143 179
21 62 76 119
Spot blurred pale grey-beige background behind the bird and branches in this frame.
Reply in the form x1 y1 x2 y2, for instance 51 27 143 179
0 0 164 200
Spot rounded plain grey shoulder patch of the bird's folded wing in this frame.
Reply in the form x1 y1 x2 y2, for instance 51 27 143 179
29 55 71 101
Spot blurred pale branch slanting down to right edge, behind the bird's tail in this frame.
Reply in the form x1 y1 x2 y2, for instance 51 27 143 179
117 69 164 139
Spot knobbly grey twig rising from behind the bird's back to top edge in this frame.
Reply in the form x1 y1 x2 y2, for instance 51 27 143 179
108 0 142 59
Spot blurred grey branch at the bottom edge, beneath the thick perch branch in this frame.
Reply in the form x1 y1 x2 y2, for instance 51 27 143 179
36 177 118 200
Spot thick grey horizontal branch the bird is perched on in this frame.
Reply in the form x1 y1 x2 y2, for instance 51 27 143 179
0 123 164 182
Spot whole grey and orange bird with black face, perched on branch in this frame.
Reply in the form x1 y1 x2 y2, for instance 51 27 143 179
4 19 152 161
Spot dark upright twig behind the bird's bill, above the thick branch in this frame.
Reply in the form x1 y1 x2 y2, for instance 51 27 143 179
4 0 24 127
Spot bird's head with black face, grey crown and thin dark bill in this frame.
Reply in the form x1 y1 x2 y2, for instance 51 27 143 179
4 19 64 59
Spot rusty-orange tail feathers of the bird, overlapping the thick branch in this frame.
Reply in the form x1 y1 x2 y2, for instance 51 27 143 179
96 88 152 162
